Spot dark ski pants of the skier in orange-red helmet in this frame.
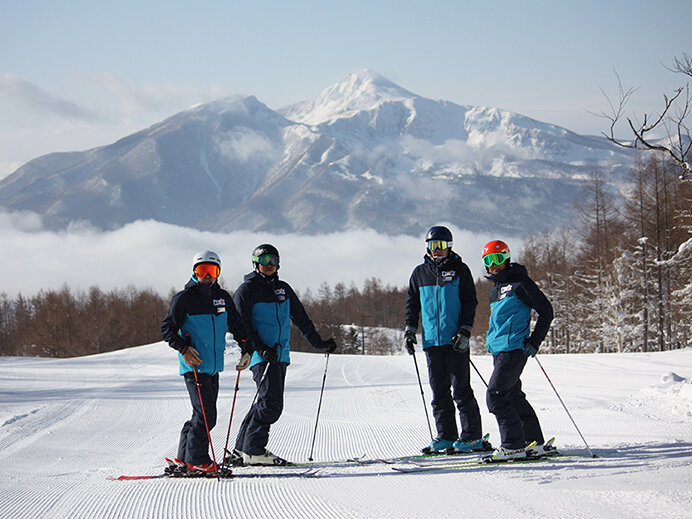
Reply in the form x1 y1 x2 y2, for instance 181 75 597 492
486 350 544 449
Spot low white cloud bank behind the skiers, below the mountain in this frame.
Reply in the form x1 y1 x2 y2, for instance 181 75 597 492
0 212 519 297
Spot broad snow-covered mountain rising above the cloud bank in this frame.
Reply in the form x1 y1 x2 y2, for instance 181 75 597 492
0 70 633 235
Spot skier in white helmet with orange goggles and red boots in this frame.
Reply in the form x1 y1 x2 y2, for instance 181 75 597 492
161 251 251 473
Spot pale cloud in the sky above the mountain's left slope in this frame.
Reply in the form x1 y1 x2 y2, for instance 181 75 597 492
0 73 223 180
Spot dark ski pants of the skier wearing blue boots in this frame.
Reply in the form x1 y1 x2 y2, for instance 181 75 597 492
424 344 483 441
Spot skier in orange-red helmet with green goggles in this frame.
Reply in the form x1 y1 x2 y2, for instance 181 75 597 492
482 240 553 460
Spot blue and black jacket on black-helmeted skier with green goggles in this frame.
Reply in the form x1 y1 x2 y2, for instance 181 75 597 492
233 272 322 367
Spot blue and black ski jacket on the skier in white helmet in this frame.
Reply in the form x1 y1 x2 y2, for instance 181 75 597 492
161 277 249 375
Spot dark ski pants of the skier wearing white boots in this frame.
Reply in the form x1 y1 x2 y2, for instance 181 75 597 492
235 362 288 455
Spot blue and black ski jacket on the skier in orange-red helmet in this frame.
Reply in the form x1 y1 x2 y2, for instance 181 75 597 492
485 263 553 355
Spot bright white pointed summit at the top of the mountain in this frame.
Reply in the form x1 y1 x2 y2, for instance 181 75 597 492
279 69 418 126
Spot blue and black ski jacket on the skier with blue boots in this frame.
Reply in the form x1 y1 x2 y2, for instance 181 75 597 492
406 250 478 349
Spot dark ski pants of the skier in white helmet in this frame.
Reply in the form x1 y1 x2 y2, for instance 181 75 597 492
178 373 219 465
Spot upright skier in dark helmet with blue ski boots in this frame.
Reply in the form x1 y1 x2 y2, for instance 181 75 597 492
404 226 490 454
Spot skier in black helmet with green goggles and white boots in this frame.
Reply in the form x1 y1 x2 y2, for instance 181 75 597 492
231 243 336 465
